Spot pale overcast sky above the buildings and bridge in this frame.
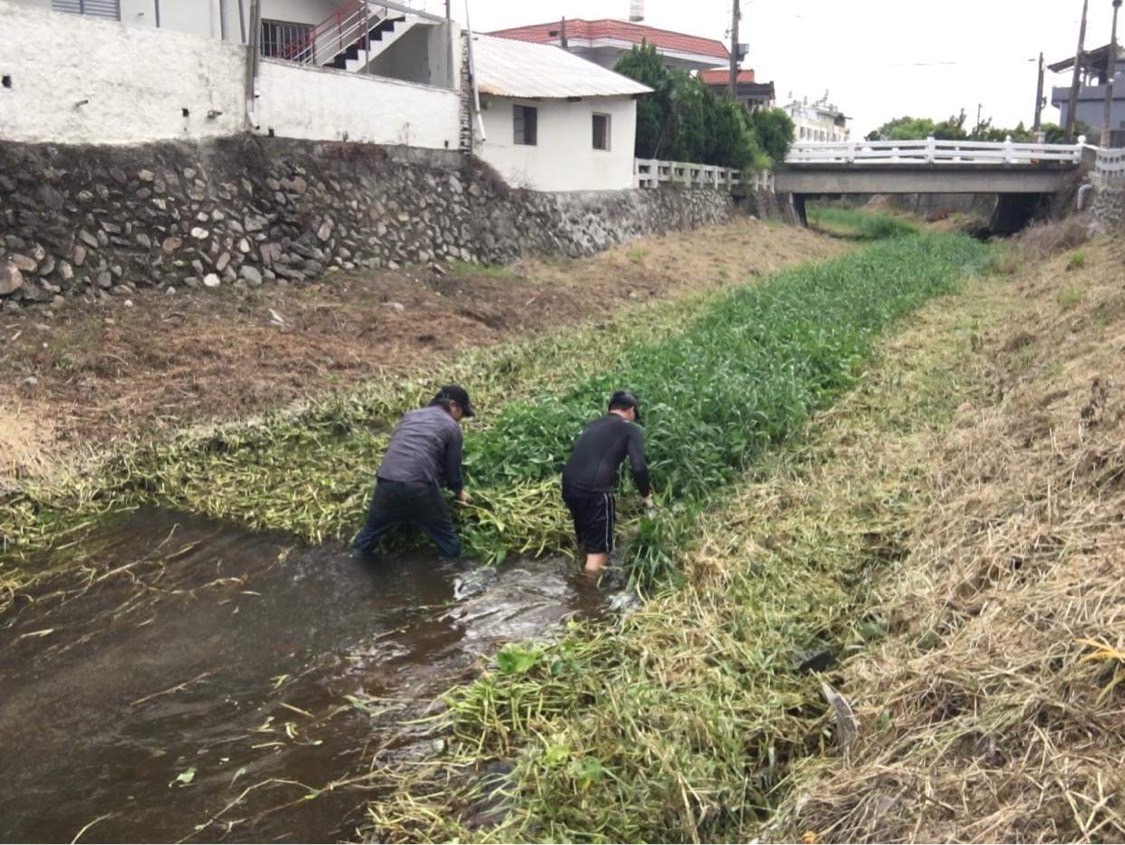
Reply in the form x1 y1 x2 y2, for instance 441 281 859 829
417 0 1125 137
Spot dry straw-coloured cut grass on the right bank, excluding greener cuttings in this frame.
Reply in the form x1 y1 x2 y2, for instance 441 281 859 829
779 233 1125 842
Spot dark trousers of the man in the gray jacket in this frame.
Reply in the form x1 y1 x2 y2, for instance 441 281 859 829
353 478 461 557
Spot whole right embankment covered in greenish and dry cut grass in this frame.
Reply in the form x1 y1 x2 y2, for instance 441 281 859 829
366 218 1125 842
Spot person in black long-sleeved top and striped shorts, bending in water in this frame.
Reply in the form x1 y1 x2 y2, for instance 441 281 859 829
563 390 653 574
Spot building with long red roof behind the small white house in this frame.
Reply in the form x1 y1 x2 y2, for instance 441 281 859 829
491 18 730 71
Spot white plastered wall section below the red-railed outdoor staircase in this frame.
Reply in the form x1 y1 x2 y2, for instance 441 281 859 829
259 60 461 150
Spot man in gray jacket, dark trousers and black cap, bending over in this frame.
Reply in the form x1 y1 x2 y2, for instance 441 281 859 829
354 385 474 558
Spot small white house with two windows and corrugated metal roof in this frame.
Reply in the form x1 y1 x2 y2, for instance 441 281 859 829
473 35 651 191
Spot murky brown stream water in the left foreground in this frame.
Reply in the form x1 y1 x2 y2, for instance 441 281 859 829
0 511 604 842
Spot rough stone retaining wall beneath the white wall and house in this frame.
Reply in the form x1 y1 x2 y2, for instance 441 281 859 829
0 135 734 309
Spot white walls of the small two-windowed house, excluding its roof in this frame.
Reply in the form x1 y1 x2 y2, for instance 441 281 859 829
479 97 637 191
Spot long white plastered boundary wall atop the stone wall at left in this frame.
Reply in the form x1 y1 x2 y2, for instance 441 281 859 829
0 0 460 150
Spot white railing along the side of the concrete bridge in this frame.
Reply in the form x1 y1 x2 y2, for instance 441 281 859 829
785 137 1086 165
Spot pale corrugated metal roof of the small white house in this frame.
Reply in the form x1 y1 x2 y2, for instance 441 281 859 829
473 35 653 99
